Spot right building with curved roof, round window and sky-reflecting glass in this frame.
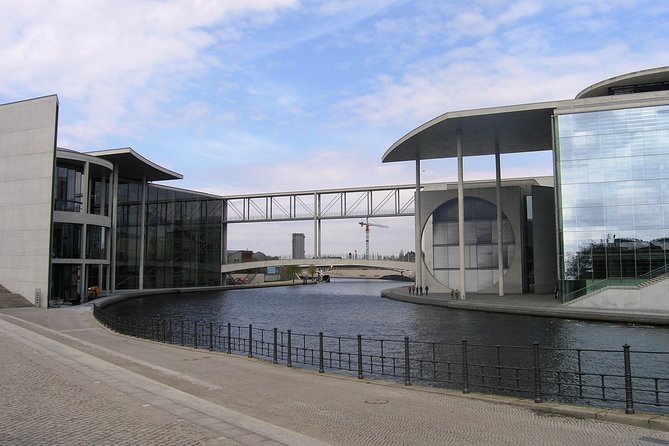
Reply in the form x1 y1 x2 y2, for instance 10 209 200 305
383 67 669 311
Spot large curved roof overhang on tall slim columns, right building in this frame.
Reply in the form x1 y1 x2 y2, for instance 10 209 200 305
382 101 566 163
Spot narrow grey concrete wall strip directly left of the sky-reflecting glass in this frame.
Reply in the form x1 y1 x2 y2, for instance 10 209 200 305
532 186 557 294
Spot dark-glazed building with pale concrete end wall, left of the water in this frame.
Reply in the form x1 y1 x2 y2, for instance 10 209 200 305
0 96 225 307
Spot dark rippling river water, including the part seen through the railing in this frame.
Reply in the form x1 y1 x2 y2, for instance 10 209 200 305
108 280 669 413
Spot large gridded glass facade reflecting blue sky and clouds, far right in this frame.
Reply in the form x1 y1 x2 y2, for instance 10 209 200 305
556 106 669 300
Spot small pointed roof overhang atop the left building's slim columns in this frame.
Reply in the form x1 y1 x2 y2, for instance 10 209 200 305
86 147 183 181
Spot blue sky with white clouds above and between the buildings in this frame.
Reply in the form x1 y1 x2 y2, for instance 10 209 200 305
0 0 669 255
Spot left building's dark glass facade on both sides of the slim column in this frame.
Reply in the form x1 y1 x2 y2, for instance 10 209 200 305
116 180 223 289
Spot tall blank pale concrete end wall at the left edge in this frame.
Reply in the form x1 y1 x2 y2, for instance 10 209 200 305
0 96 58 307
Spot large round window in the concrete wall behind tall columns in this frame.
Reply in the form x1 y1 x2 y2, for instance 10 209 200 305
432 197 515 291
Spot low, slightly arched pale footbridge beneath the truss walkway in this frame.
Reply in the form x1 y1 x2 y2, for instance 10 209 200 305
221 258 416 274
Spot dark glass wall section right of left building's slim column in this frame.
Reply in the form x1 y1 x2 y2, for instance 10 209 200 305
144 185 223 288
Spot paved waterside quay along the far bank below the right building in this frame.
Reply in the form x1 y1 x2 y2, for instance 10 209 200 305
382 286 669 325
